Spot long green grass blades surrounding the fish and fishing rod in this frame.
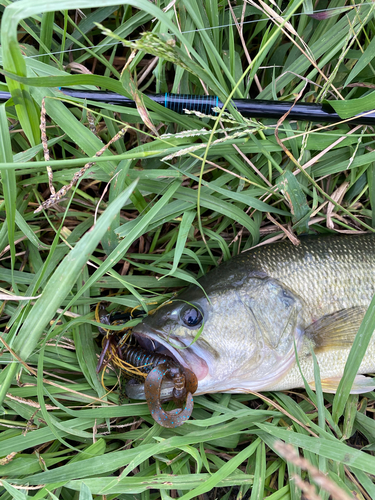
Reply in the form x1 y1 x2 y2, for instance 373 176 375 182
0 0 375 500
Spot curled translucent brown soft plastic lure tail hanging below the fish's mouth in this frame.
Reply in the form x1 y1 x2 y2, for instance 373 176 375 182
145 363 197 429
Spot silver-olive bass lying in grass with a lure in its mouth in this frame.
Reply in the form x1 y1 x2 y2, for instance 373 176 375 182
131 234 375 399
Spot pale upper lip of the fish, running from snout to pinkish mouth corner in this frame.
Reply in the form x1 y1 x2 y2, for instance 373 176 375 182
132 323 209 381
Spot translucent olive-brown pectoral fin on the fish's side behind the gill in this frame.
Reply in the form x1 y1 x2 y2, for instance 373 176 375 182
305 307 366 353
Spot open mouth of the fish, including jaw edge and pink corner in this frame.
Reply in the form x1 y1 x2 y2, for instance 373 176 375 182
132 323 209 381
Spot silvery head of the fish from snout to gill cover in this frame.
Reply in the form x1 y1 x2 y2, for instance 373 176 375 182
133 275 304 394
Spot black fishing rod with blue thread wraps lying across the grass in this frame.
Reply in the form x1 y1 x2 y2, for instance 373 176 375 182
0 88 375 125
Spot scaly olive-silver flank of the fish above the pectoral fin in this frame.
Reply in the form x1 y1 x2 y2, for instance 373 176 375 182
250 235 375 317
